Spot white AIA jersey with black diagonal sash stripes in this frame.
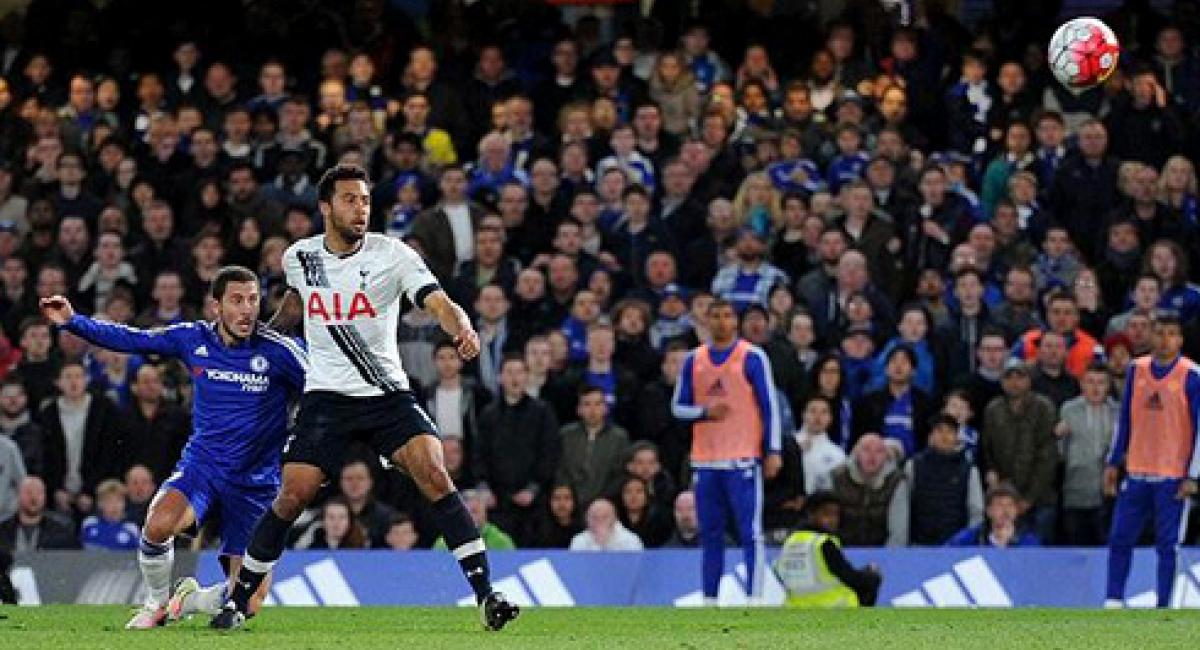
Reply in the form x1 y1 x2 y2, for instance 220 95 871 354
283 233 438 397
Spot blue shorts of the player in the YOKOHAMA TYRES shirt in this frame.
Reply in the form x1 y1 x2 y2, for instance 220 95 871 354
161 462 280 555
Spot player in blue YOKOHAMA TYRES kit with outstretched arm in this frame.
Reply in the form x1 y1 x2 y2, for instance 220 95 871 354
41 266 308 630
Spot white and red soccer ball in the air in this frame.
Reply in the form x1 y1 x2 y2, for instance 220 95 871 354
1046 17 1121 89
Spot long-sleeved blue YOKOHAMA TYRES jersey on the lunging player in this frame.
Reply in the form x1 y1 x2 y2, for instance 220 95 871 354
66 315 308 486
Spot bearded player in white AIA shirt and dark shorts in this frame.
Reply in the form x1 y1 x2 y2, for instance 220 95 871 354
212 164 518 630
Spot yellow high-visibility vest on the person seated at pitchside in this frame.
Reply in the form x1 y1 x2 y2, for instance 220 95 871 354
774 530 858 608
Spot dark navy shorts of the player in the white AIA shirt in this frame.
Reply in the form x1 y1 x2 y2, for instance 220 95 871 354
283 391 438 480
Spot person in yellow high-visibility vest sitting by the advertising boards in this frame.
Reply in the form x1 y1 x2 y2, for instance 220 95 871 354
774 490 883 608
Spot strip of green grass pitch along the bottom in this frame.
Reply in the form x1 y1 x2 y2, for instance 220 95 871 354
0 606 1200 650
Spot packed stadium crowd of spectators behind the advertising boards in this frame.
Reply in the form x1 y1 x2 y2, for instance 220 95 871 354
0 0 1200 558
